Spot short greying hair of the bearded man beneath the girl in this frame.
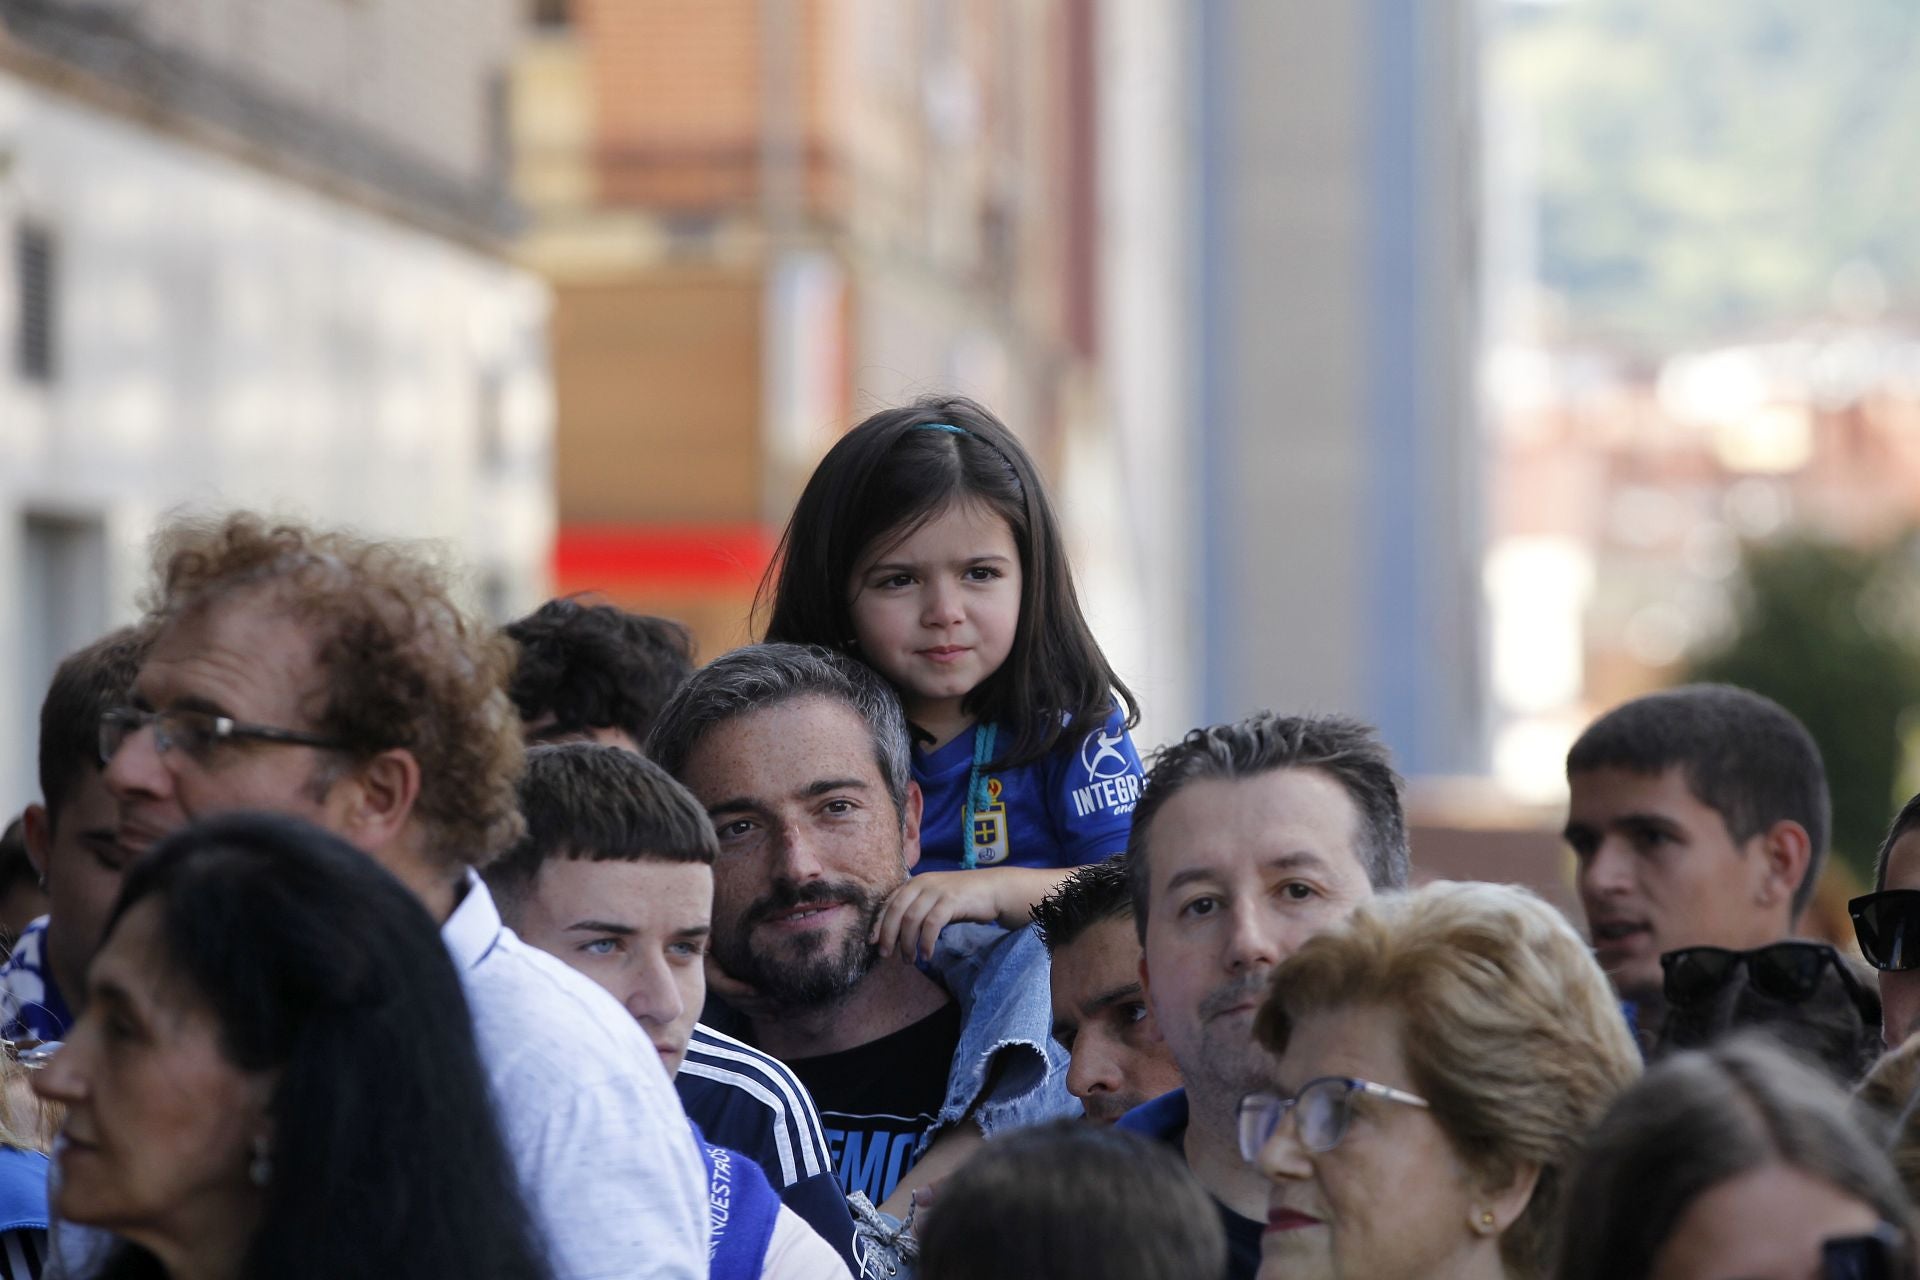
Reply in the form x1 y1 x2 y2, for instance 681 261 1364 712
647 645 912 814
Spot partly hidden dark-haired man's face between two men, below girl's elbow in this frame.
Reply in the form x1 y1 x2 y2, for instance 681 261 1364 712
1033 854 1181 1125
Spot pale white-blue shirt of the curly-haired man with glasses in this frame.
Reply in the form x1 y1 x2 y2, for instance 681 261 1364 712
440 873 707 1280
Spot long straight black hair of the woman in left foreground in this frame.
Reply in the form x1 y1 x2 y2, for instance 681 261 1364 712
100 814 552 1280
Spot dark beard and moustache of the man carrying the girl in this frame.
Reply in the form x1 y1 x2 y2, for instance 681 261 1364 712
714 881 891 1011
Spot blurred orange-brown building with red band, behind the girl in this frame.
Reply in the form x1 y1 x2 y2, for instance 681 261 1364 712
515 0 1098 675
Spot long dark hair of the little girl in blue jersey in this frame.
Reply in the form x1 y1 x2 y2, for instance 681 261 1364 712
756 397 1140 770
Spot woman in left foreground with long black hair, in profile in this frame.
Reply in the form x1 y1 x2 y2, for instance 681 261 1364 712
35 814 547 1280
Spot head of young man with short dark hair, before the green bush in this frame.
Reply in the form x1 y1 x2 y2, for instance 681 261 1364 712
1567 685 1832 1044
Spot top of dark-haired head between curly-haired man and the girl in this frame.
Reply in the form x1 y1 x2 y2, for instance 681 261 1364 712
505 597 693 750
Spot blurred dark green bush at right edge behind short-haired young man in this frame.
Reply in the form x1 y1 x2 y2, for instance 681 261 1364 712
1688 537 1920 875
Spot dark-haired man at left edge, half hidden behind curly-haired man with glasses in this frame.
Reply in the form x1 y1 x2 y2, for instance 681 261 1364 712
0 628 150 1042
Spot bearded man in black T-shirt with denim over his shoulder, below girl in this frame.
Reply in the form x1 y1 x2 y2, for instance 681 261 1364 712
647 645 1073 1217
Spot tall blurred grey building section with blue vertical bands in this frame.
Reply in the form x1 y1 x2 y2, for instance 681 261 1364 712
1179 0 1488 775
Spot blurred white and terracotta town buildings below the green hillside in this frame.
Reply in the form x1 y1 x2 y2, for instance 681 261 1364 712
1488 320 1920 796
